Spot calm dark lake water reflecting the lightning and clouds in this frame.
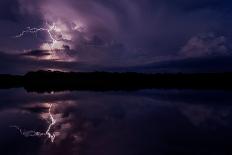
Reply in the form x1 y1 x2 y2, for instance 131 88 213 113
0 89 232 155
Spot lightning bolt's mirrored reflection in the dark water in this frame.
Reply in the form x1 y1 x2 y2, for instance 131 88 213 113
10 104 56 143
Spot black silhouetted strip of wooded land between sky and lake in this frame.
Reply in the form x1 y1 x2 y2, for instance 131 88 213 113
0 71 232 93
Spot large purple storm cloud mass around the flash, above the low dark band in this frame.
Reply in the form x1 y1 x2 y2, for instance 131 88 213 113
0 0 232 73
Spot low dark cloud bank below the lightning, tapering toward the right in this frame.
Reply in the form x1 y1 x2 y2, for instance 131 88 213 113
0 52 99 74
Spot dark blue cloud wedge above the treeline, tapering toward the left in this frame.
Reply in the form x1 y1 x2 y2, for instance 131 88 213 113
128 56 232 73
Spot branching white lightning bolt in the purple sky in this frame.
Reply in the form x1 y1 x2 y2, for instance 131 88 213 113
14 23 59 49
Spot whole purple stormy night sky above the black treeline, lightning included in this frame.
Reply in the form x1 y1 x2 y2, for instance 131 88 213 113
0 0 232 74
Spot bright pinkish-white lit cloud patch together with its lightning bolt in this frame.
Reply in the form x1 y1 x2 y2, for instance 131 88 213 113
15 20 84 61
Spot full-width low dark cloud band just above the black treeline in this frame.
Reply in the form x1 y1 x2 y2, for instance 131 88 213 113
0 49 232 74
